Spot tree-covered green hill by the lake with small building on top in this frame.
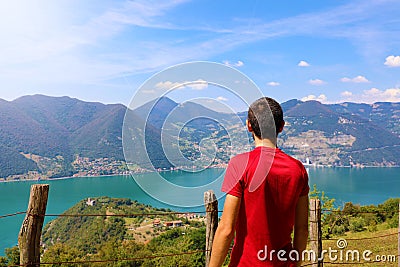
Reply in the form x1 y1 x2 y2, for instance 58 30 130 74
42 197 152 254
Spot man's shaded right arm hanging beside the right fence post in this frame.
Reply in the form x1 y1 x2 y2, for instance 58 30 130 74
293 195 308 266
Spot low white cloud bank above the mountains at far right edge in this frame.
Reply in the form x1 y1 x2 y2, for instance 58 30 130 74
341 87 400 104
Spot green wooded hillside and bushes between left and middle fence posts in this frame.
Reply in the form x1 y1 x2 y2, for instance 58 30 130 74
37 197 205 266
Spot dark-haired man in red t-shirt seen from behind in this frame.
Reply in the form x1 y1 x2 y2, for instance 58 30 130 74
209 97 309 267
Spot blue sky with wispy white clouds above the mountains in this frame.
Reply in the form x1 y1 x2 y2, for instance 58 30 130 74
0 0 400 108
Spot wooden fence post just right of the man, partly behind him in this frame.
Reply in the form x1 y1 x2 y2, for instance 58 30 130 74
310 199 323 267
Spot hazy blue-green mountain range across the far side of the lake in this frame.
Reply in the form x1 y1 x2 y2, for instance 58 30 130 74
0 95 400 178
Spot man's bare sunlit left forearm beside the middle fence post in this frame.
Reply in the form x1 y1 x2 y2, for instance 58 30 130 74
209 194 241 267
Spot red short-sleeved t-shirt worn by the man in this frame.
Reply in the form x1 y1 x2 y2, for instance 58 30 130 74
222 147 309 267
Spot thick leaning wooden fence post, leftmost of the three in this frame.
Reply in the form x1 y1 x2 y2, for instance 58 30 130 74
18 184 49 267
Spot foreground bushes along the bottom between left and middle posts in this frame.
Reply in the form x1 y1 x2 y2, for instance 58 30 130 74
42 223 205 267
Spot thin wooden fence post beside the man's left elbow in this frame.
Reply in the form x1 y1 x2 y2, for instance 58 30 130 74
204 190 218 266
